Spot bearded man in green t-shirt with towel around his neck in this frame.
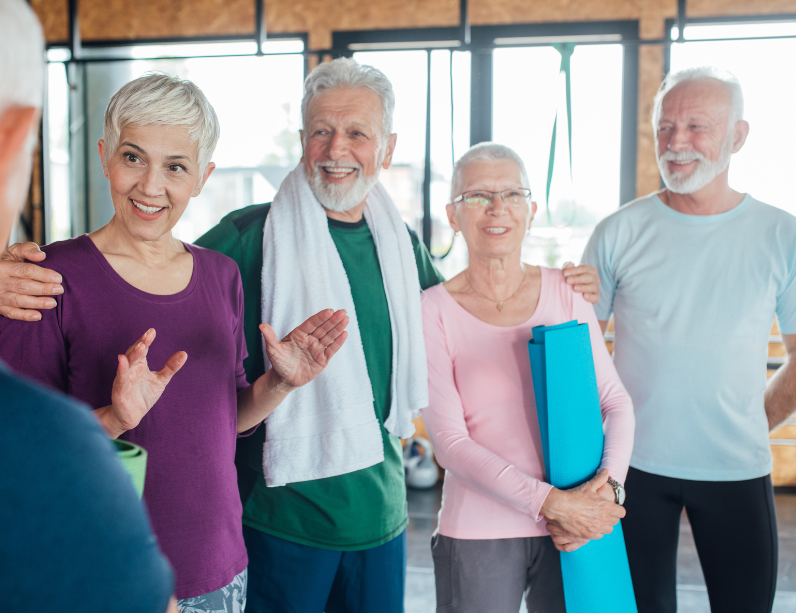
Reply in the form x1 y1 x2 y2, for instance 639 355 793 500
197 59 443 613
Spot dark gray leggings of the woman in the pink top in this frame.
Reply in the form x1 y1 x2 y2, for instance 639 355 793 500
431 534 566 613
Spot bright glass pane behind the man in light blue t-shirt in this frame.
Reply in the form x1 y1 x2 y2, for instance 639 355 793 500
671 22 796 214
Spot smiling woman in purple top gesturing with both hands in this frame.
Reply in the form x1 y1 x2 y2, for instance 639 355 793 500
0 74 348 611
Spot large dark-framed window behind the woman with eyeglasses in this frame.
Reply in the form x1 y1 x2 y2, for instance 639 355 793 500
334 22 638 277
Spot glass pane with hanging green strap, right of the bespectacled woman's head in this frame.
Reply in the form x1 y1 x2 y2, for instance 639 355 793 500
492 44 623 267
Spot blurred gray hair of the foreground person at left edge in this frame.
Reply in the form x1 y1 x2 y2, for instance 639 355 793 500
0 0 44 113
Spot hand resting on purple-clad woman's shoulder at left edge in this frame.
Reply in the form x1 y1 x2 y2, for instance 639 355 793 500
0 243 64 321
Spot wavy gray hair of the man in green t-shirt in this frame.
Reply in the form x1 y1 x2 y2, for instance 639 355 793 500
301 57 395 138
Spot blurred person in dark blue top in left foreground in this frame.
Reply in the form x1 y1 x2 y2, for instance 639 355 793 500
0 0 176 613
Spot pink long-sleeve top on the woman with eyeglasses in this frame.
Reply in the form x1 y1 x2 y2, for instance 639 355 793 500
422 268 634 539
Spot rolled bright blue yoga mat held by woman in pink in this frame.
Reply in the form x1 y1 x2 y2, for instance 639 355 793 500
528 321 638 613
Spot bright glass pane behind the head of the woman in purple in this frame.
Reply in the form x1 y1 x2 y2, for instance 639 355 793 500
76 41 304 241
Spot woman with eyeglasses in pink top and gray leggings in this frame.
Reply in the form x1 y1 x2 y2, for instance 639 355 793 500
422 143 634 613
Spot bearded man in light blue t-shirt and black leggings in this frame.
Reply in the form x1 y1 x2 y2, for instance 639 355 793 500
583 68 796 613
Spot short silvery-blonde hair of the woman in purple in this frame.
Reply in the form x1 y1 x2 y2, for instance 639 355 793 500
102 72 221 172
